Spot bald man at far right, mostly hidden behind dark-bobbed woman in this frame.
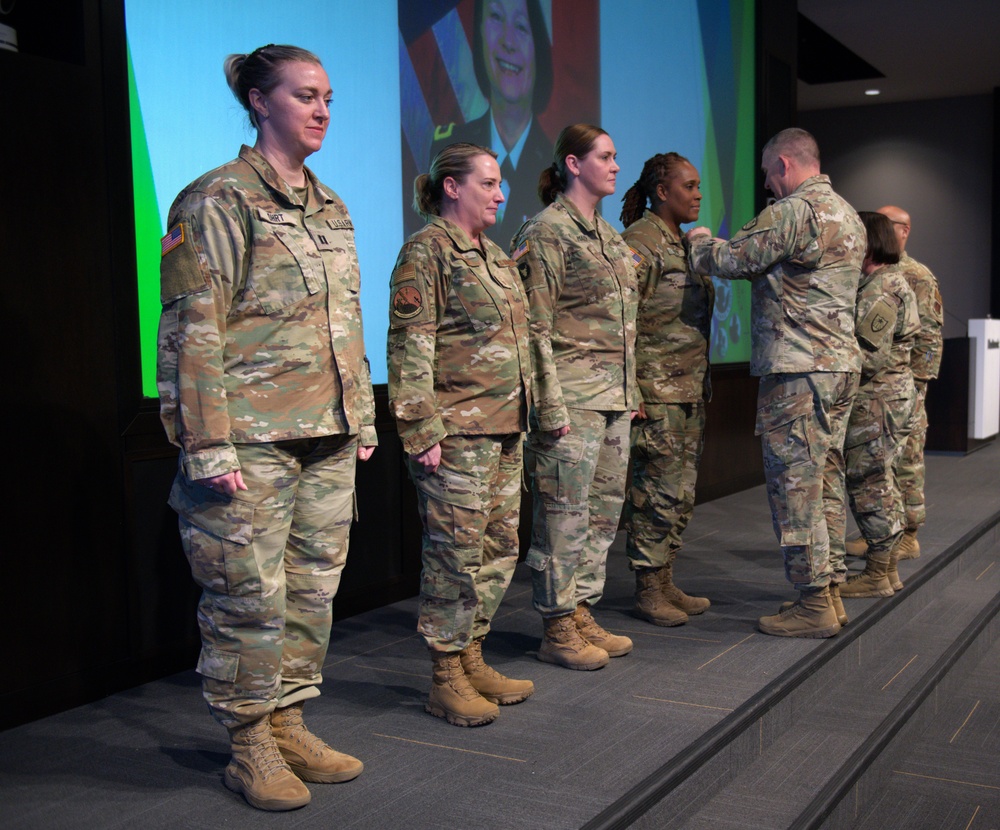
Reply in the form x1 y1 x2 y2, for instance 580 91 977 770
878 205 944 559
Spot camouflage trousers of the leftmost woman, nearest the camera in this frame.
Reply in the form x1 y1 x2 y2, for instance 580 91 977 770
170 435 358 727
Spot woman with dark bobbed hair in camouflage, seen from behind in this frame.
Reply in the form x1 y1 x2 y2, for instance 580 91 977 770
831 212 920 597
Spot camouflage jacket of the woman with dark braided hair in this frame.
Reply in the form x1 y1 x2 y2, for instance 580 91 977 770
622 210 715 410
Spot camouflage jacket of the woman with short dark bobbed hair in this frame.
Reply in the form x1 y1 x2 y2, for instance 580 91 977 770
857 264 920 400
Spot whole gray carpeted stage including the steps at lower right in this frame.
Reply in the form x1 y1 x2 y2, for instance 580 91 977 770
0 442 1000 830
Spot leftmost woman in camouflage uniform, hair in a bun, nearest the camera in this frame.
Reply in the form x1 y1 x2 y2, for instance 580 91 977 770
157 44 377 810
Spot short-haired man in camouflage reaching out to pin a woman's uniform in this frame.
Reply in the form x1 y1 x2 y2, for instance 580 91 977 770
688 129 865 637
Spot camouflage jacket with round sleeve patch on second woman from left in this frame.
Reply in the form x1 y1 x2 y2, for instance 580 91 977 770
388 217 531 454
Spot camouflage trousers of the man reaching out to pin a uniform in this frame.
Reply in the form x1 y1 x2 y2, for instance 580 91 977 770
756 372 859 591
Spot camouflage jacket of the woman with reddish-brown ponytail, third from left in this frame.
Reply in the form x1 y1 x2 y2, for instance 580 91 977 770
511 195 639 430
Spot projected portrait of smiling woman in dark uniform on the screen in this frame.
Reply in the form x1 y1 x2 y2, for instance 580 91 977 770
431 0 552 247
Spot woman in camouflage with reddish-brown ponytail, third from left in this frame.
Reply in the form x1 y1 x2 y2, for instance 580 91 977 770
512 124 638 670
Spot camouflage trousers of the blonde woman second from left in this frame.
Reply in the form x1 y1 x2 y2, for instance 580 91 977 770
408 432 523 652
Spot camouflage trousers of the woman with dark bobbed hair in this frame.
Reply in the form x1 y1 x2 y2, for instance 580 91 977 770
841 389 914 562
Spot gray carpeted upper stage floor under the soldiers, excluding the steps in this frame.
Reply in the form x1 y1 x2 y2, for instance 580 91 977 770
0 442 1000 830
